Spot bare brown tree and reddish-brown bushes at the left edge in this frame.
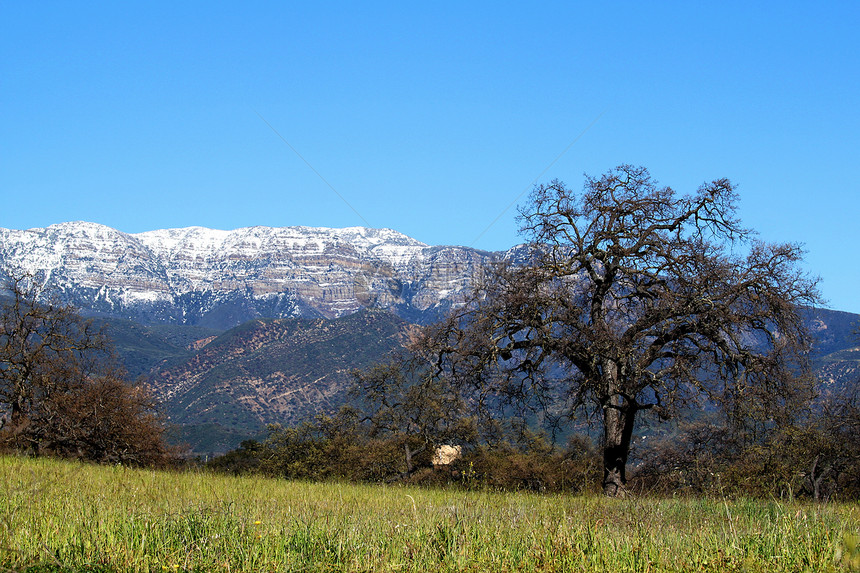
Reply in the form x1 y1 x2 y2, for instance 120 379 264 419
0 276 173 465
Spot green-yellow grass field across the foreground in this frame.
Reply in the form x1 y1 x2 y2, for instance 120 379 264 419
0 457 860 572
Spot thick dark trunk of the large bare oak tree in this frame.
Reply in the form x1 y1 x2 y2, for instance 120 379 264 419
603 398 636 497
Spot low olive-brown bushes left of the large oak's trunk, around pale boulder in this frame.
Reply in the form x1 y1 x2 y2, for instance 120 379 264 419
207 409 601 493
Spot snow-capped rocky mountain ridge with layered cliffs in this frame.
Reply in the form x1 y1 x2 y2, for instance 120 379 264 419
0 222 504 328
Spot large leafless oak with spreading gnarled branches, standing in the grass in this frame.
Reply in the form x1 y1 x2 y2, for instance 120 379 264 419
422 165 819 496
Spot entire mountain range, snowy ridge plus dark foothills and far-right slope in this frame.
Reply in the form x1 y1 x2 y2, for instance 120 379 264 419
0 222 860 452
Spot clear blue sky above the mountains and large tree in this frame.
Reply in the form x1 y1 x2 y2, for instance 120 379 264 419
0 2 860 312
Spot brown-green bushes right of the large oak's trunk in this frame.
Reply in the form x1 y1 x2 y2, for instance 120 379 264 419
635 394 860 500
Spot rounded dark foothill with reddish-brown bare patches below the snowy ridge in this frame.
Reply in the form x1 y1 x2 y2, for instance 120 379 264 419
148 310 411 444
